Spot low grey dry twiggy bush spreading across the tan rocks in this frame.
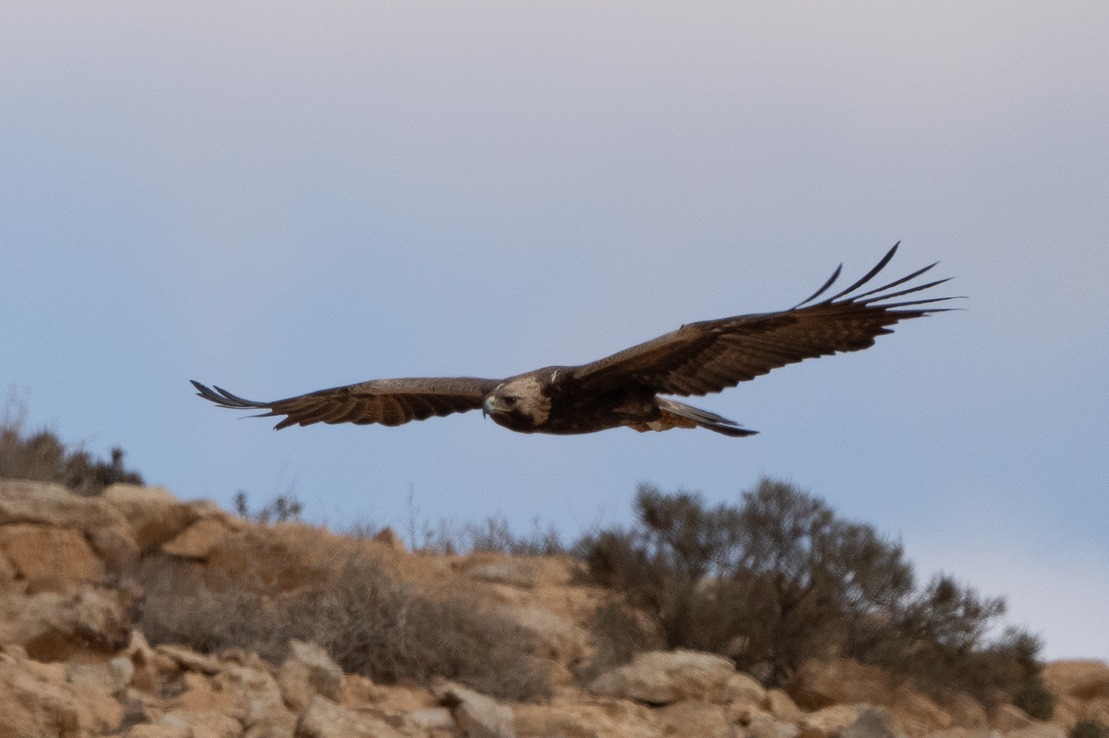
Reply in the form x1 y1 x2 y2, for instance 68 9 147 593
139 554 553 700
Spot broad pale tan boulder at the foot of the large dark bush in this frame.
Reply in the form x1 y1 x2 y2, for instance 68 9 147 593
589 649 735 705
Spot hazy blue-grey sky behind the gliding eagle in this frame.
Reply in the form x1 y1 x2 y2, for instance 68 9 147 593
0 0 1109 658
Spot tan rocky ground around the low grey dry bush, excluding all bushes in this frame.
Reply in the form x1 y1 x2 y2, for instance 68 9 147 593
0 481 1109 738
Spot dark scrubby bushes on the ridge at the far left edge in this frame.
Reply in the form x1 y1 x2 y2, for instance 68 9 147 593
0 390 143 496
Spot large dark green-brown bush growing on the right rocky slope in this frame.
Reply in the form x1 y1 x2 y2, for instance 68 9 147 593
579 479 1051 716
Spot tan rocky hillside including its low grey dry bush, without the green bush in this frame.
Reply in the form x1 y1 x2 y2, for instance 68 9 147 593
0 481 1109 738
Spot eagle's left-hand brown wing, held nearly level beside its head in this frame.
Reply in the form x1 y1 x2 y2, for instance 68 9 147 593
193 376 500 431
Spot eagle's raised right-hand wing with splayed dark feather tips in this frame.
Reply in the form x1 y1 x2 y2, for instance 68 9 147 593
572 244 953 395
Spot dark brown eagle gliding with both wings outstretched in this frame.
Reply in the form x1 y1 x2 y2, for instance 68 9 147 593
193 244 954 436
